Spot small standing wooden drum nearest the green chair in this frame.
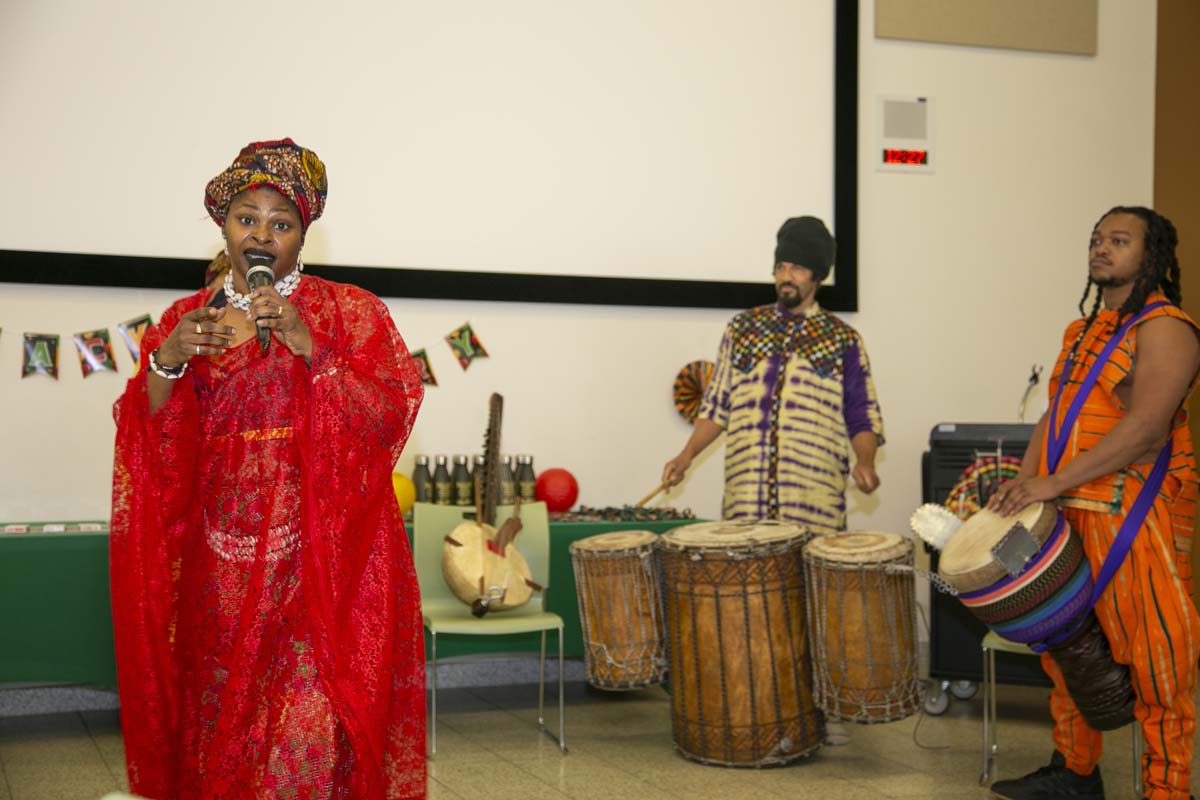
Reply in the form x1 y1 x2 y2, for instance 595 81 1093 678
570 530 666 690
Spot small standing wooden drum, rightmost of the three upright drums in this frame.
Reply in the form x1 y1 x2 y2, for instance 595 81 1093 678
804 531 920 722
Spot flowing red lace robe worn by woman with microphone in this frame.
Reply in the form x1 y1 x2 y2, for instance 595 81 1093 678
110 277 425 800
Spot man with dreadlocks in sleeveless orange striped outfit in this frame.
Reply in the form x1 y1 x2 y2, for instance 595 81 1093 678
989 206 1200 800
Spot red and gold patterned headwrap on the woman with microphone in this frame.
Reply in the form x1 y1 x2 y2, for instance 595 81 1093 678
204 139 329 230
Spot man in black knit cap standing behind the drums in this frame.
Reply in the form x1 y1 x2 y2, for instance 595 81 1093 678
662 217 883 534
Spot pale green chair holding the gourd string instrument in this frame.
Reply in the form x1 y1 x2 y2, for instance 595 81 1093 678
413 503 566 757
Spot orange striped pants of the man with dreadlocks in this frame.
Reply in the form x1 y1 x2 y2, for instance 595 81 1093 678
1042 470 1200 800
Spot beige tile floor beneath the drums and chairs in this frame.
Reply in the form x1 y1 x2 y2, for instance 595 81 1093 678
0 684 1185 800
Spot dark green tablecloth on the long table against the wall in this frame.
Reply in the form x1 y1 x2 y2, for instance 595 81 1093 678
0 521 690 686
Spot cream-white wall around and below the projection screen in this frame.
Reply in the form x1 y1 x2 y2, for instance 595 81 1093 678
0 0 1154 554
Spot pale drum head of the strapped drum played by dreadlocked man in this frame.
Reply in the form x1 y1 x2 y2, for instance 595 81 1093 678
937 503 1058 591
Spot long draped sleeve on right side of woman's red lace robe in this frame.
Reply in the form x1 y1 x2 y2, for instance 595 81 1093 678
300 283 425 798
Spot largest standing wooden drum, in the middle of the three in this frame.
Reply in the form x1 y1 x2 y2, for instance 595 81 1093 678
659 522 824 766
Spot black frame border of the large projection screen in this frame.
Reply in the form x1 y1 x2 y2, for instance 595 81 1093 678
0 0 859 312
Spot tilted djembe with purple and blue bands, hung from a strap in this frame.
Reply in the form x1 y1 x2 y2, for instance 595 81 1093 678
937 503 1135 730
